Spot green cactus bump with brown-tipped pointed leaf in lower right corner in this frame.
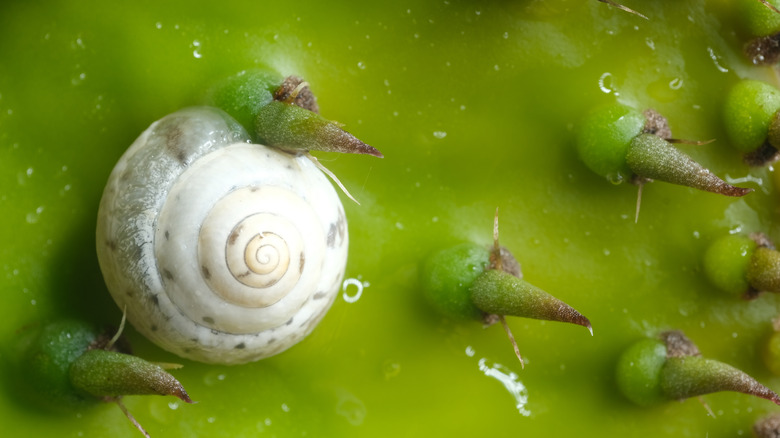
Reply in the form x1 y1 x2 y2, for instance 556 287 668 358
616 330 780 406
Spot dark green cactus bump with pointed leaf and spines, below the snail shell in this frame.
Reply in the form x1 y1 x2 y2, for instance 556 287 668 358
17 320 192 437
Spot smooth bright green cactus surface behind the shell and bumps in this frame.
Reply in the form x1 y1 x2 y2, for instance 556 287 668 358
0 0 780 438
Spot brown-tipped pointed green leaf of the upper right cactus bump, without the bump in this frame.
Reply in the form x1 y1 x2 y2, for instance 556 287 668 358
626 134 753 196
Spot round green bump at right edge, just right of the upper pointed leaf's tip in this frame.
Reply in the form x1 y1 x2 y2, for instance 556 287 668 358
723 80 780 166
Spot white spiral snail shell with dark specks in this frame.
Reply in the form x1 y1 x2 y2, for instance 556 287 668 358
97 107 348 364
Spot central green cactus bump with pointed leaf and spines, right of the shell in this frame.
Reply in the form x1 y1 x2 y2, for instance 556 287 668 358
420 209 593 367
